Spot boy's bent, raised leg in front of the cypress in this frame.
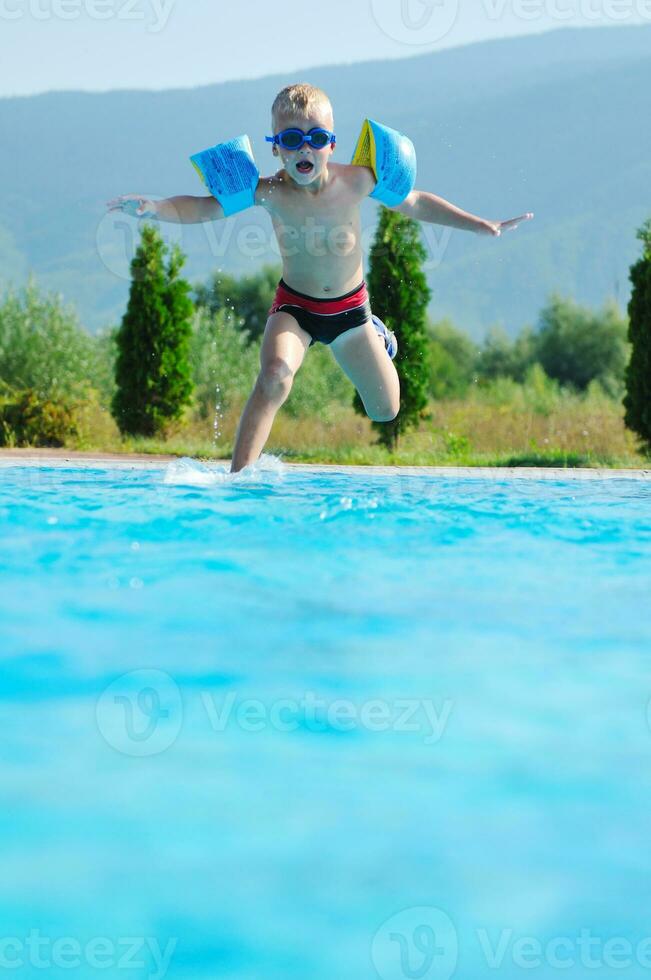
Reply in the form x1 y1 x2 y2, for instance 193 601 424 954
330 320 400 422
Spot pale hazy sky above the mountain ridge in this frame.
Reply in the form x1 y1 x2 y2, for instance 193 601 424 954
0 0 651 96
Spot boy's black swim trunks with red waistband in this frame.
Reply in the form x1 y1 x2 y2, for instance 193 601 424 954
269 279 371 347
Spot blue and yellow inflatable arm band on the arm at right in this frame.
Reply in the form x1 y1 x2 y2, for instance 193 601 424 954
351 119 416 207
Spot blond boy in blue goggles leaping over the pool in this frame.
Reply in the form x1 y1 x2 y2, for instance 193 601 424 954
108 84 533 473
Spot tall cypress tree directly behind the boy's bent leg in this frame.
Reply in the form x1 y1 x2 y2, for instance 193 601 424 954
354 208 431 450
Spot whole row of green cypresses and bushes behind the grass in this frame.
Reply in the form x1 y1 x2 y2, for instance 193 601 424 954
0 209 651 451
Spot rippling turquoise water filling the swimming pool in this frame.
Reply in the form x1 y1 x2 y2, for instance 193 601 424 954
0 459 651 980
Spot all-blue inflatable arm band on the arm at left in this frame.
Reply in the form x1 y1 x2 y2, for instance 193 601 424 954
190 136 260 215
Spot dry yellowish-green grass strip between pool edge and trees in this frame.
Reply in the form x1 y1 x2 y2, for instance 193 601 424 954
10 374 651 468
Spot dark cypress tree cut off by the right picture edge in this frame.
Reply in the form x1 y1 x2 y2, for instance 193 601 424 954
624 218 651 452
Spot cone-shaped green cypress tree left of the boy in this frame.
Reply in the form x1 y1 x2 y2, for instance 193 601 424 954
112 224 194 436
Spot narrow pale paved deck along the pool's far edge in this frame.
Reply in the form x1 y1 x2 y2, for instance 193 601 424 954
0 449 651 480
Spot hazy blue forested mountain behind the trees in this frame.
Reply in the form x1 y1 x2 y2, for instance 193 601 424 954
0 25 651 338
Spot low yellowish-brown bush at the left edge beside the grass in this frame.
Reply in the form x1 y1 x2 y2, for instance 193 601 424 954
0 389 78 447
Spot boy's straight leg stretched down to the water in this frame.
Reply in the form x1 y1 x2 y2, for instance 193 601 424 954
231 313 310 473
